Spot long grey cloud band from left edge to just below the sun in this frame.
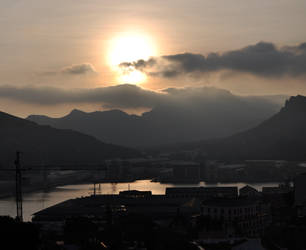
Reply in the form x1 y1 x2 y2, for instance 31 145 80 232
0 84 164 108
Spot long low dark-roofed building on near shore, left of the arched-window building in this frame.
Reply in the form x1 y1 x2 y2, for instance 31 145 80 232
32 190 201 233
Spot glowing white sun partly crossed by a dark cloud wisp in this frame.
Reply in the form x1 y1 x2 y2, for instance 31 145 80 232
108 33 156 84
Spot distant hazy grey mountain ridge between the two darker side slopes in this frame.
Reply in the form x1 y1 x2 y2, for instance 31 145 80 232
27 88 283 147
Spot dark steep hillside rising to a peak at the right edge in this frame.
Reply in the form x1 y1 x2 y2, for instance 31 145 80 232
187 95 306 160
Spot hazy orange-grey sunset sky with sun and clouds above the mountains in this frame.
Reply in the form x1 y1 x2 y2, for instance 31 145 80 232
0 0 306 117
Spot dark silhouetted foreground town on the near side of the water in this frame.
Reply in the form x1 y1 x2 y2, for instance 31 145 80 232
1 174 306 250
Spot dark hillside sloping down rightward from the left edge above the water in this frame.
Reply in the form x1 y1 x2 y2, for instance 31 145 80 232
0 112 137 166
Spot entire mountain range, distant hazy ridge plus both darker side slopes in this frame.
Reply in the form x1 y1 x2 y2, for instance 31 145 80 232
0 90 306 162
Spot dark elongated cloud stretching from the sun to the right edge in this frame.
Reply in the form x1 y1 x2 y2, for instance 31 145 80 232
120 42 306 78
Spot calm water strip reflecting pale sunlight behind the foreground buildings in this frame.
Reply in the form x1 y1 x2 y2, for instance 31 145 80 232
0 180 278 221
